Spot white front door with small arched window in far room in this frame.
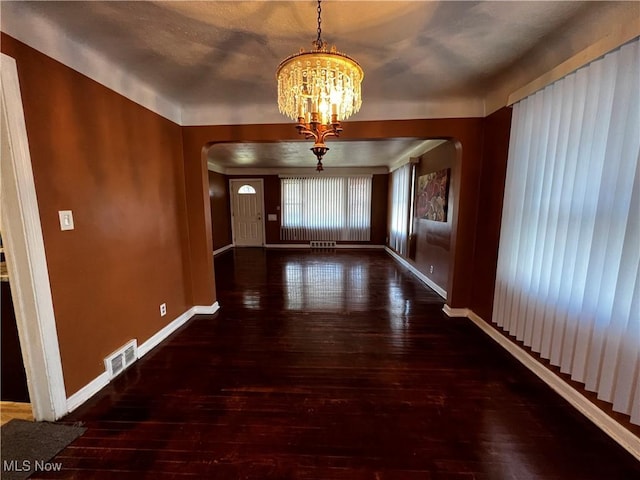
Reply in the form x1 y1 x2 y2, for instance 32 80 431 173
230 179 264 247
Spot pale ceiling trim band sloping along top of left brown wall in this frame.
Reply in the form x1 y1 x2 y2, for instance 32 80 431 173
2 2 182 125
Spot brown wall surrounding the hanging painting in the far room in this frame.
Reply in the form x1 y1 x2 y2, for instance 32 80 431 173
413 142 460 291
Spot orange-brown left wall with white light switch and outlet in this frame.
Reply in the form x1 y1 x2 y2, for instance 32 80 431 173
1 34 198 395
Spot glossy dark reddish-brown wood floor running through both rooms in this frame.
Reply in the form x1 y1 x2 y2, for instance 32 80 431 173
41 249 640 480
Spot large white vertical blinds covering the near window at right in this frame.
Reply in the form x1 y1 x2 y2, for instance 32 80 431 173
493 39 640 424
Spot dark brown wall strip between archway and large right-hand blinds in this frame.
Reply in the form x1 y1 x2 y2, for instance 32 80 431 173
469 107 512 321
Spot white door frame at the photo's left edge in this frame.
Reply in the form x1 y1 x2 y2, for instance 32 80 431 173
0 54 68 421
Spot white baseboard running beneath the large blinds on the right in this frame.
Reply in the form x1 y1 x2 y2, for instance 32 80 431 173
460 305 640 460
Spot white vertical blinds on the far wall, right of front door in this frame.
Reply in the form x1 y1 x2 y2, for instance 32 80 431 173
280 176 371 241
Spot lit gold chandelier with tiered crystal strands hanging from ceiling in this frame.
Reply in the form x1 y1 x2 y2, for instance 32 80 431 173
276 0 364 171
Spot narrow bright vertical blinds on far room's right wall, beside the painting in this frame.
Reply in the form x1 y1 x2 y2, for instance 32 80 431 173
389 163 411 257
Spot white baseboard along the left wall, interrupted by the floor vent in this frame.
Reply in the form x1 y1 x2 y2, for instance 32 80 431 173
67 302 220 413
